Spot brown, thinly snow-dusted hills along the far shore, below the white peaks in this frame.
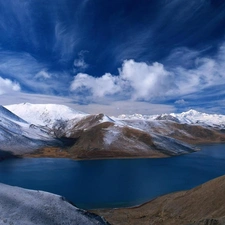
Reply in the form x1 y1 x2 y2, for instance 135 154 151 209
22 114 225 159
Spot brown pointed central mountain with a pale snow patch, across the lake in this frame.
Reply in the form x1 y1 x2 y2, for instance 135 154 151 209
25 114 195 159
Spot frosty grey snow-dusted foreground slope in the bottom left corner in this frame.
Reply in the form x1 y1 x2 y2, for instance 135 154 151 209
0 184 109 225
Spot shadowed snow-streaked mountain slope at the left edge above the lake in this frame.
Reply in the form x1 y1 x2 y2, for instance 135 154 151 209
0 106 56 158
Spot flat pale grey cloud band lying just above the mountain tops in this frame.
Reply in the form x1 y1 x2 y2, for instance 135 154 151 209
0 92 176 116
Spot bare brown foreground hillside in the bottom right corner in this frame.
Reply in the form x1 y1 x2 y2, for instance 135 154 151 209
94 176 225 225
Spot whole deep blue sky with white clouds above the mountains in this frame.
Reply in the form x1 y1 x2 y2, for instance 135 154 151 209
0 0 225 115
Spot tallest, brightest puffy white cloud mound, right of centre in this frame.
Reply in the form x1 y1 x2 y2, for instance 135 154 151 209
119 60 174 100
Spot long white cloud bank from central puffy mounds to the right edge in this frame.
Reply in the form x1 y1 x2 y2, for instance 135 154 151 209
70 41 225 102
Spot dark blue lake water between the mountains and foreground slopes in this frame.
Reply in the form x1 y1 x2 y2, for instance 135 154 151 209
0 144 225 208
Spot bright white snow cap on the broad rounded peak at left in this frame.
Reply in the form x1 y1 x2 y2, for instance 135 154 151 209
5 103 87 127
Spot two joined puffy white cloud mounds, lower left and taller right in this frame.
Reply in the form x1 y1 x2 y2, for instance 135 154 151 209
70 60 174 100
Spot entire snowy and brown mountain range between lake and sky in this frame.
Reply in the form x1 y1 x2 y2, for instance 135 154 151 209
0 103 225 159
